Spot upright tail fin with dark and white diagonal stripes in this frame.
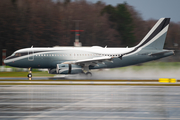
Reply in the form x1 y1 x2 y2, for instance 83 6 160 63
135 18 170 50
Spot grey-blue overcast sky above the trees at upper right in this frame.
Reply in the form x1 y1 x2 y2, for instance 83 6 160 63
87 0 180 22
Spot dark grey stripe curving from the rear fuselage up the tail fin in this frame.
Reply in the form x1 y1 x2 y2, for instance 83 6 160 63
121 18 170 57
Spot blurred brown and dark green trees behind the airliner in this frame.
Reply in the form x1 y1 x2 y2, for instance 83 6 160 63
0 0 180 64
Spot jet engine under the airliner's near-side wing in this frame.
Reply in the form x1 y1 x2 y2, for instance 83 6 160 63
48 64 83 74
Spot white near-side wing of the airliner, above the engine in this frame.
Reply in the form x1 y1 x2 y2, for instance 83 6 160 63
62 56 112 65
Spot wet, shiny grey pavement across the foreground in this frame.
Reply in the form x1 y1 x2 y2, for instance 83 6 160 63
0 85 180 120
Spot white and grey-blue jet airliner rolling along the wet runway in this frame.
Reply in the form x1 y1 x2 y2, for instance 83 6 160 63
4 18 174 77
